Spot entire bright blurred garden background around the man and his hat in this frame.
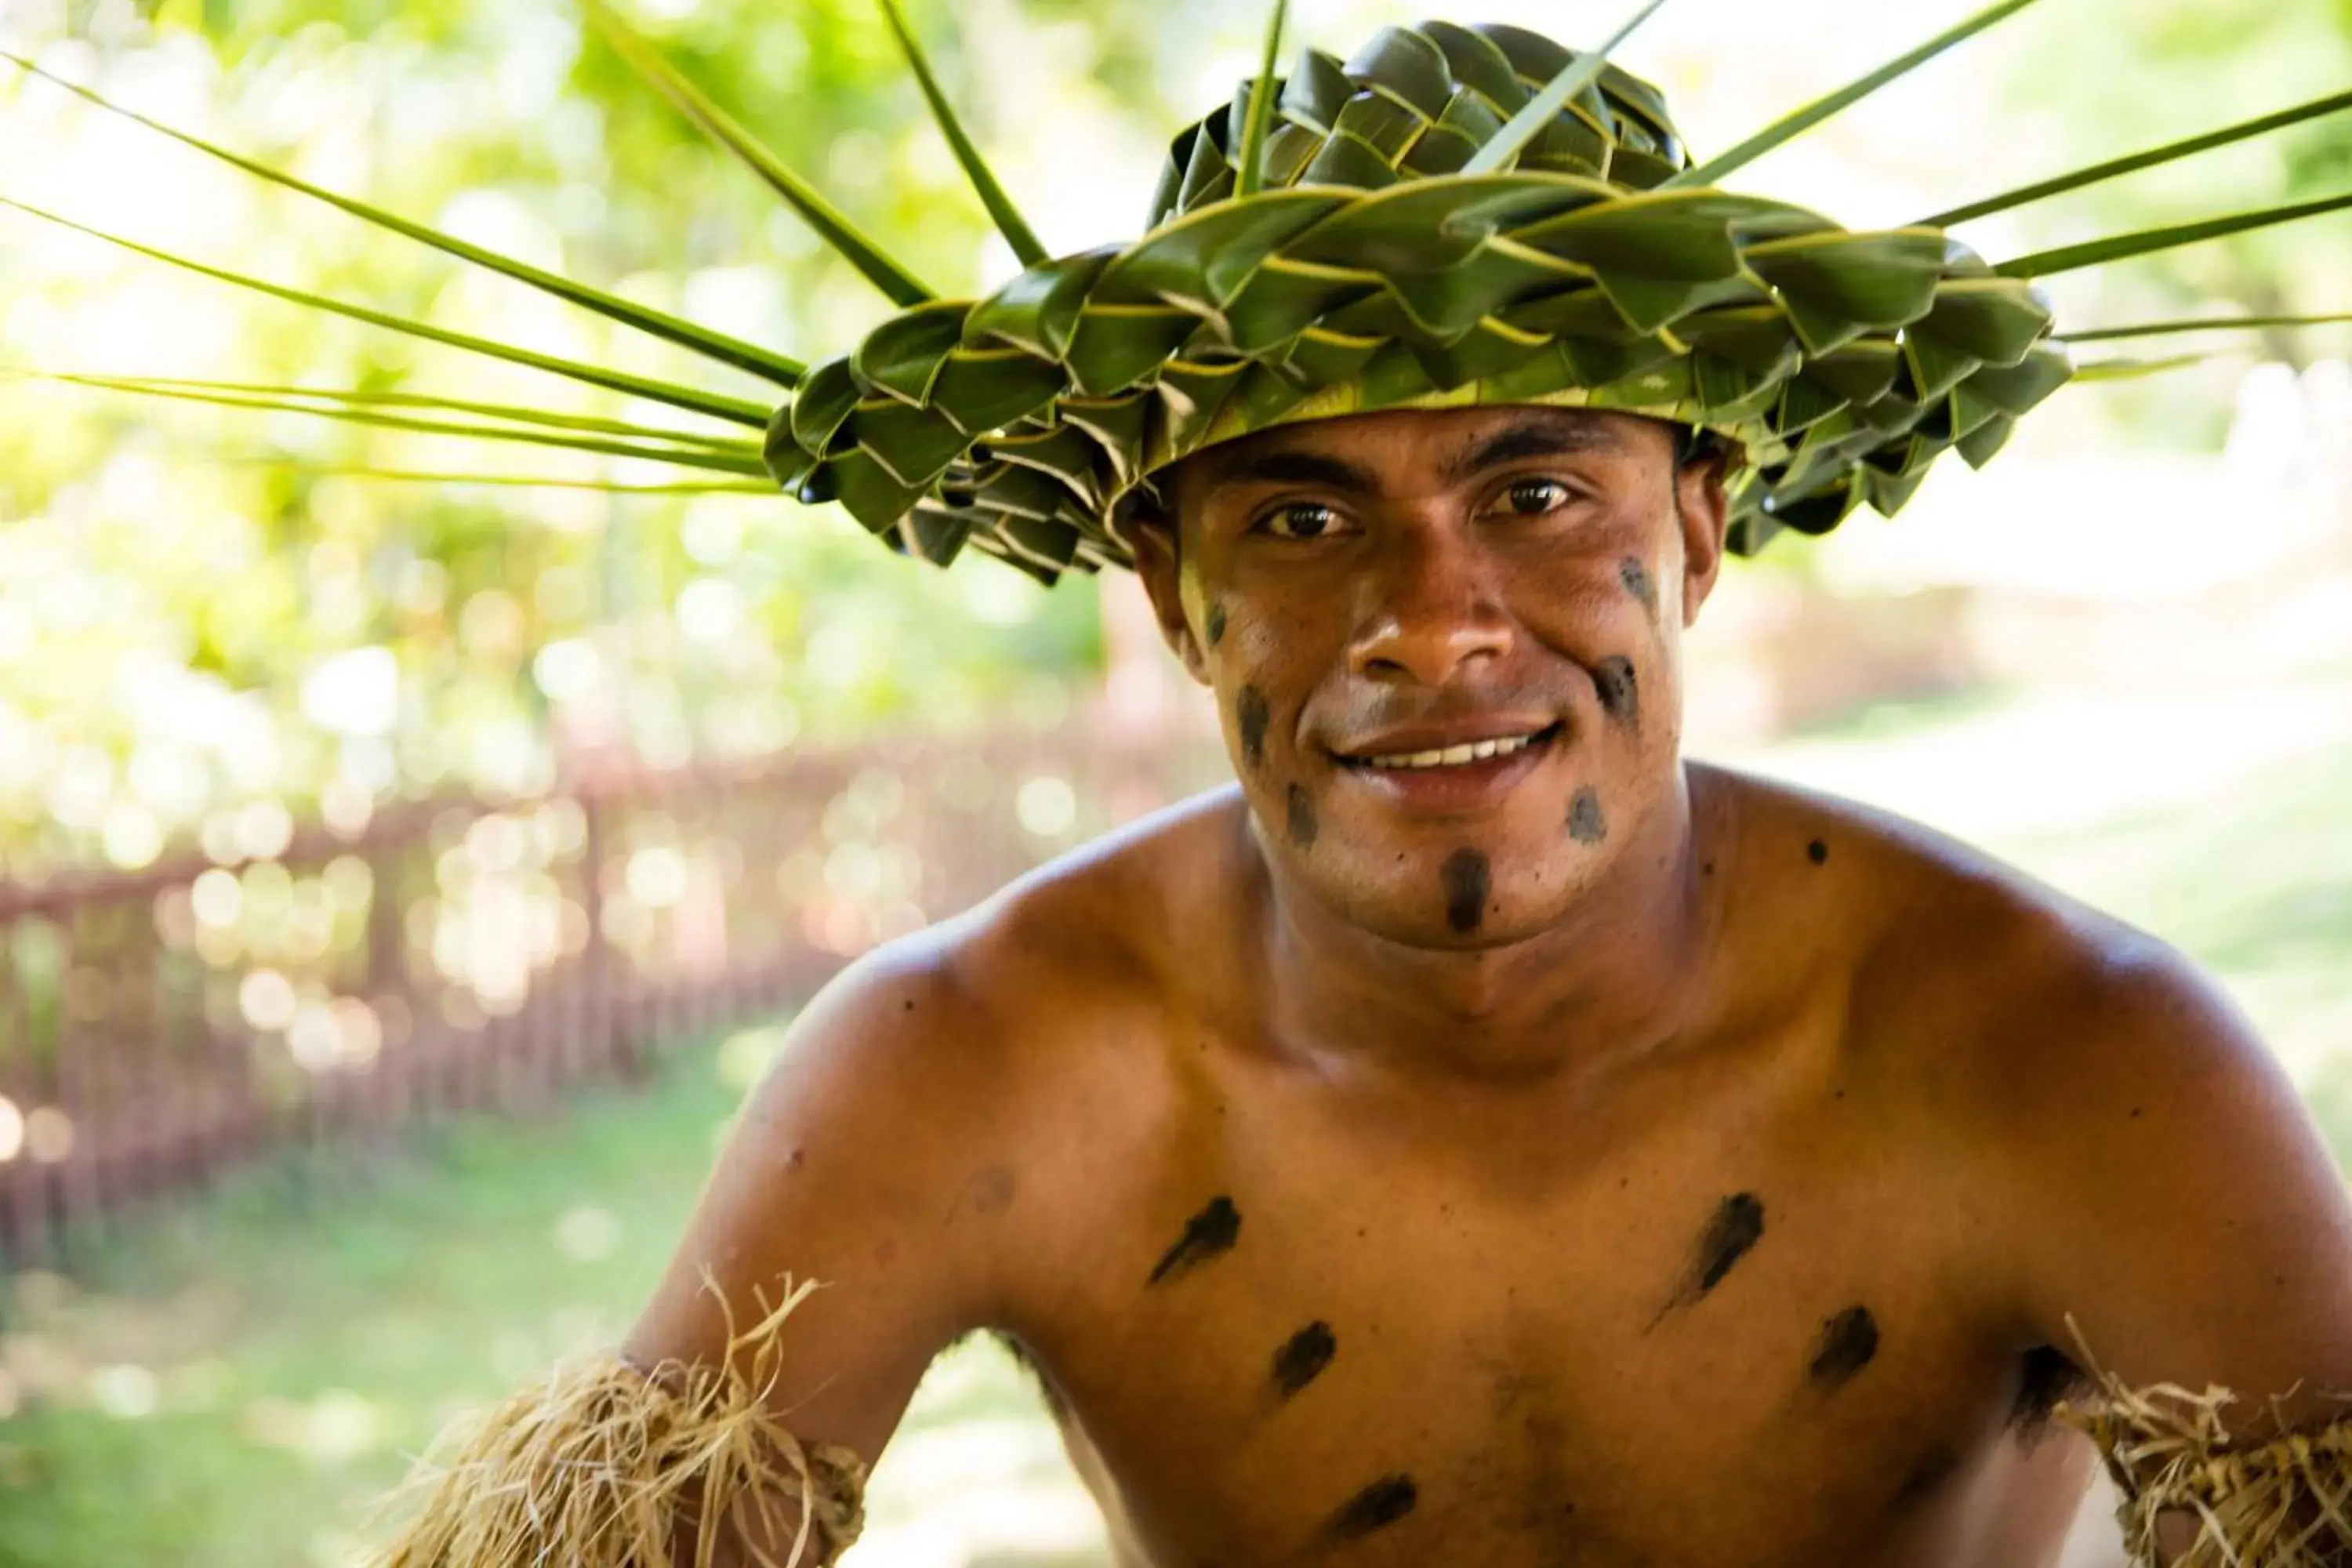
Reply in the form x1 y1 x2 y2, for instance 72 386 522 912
0 0 2352 1568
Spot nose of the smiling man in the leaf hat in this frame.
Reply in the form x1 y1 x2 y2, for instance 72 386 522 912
1348 527 1512 687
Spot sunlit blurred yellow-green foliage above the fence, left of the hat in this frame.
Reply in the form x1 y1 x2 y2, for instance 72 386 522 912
0 0 1289 874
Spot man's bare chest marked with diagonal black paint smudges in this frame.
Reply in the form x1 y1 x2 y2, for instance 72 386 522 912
997 1034 2060 1566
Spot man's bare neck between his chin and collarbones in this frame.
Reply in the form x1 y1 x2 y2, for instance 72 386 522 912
1263 764 1722 1088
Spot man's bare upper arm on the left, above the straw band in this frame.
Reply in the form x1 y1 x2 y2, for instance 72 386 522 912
623 926 1014 1462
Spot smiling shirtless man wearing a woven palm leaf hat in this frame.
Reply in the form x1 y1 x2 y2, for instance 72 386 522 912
343 5 2352 1568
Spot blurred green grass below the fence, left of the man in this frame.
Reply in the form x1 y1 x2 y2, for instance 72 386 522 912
0 1032 1077 1568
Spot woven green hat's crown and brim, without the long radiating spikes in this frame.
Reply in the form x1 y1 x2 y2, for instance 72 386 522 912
767 24 2072 581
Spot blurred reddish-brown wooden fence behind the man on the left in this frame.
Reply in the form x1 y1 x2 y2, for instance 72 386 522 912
0 729 1221 1267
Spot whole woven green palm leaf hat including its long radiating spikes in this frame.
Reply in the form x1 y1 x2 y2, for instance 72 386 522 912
0 0 2352 583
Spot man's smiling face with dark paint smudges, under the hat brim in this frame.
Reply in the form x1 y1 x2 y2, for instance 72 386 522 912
1136 407 1724 947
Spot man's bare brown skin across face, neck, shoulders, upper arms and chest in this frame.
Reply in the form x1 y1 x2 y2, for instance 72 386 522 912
628 409 2352 1568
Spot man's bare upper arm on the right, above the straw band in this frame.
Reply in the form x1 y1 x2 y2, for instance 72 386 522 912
2002 942 2352 1434
